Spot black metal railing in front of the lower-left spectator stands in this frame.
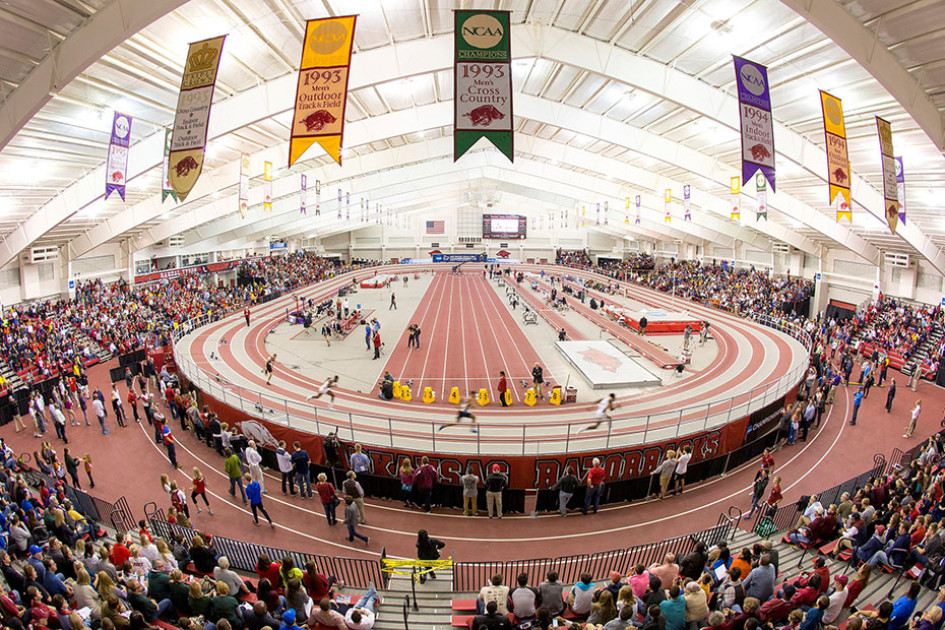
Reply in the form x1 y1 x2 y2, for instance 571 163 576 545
150 518 385 589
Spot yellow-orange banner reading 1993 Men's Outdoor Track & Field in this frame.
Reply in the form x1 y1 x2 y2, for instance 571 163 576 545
289 15 358 166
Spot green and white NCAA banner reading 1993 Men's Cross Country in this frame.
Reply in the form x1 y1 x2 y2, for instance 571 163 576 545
453 11 515 162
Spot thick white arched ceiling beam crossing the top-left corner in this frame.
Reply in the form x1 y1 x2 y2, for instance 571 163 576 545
0 0 188 151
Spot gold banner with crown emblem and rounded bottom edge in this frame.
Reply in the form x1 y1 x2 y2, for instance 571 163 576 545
168 35 226 201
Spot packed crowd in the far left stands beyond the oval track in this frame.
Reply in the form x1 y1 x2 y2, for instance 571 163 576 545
0 253 339 380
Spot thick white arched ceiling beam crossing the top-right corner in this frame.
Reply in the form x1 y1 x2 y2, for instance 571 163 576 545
781 0 945 151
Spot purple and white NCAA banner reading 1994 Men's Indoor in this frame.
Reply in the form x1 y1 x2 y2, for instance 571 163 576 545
732 55 775 191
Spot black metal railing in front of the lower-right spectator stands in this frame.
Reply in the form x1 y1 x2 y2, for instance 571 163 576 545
453 521 734 591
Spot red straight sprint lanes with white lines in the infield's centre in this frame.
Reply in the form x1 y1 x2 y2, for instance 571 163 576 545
376 272 554 402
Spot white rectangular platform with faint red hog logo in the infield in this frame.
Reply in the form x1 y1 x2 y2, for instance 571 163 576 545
555 340 663 389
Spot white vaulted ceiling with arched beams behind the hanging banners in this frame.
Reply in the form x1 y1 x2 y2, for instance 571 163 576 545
0 0 945 272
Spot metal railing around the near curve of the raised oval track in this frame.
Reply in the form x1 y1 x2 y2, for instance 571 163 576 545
171 267 812 455
